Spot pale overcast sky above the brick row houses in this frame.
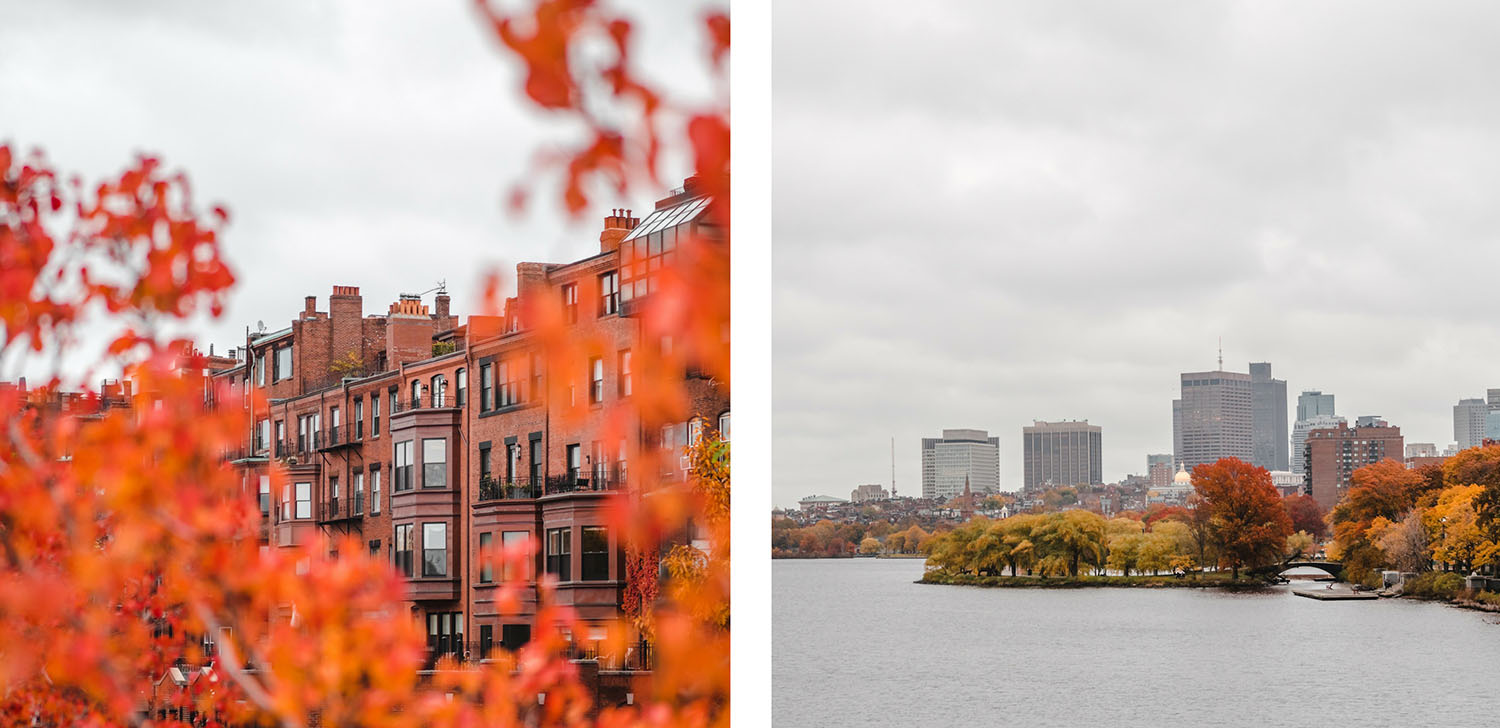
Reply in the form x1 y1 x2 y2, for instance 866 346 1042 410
0 0 710 379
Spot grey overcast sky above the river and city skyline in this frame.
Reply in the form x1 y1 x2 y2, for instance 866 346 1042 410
773 0 1500 506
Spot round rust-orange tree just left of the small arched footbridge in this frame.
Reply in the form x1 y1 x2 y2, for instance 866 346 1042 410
1193 458 1292 578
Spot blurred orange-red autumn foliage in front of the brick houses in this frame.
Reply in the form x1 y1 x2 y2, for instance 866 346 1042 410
0 2 731 726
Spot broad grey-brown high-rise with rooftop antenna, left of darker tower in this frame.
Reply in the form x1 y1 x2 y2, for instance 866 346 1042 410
1172 371 1254 470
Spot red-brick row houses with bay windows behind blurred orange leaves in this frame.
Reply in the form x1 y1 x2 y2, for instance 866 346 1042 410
213 180 731 659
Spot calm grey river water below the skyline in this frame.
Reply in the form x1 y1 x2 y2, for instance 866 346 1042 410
771 558 1500 728
